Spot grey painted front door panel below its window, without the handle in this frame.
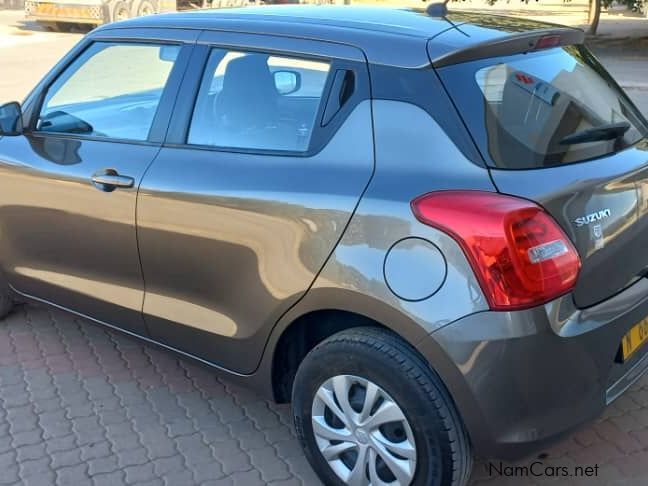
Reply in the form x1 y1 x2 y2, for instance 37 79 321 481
0 135 158 333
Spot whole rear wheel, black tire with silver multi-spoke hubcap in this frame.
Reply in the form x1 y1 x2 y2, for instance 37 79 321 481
293 328 472 486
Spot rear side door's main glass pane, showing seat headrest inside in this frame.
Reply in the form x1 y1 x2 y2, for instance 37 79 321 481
187 49 330 152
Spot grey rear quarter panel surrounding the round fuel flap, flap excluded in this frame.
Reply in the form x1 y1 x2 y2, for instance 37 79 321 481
309 100 493 343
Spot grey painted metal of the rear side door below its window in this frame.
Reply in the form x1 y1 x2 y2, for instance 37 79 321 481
137 101 374 373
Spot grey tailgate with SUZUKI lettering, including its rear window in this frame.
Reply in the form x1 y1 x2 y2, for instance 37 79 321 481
438 41 648 307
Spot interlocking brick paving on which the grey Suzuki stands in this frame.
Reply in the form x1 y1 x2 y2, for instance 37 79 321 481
0 305 648 486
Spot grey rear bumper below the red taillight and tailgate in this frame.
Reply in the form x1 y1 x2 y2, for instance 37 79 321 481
419 279 648 459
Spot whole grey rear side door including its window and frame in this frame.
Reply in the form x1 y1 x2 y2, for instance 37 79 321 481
137 32 374 373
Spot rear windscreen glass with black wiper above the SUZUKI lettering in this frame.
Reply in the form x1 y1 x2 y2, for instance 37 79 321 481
439 46 647 169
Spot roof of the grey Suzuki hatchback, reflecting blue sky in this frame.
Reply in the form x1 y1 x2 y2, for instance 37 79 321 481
98 5 576 67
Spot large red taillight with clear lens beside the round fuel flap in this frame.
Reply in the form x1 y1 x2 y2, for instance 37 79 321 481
412 191 580 310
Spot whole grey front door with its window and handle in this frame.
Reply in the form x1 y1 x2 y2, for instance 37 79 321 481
0 41 191 334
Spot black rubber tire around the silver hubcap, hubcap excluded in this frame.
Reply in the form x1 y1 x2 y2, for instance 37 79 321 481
292 328 473 486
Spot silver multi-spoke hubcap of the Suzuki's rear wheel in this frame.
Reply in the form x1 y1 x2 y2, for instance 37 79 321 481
312 375 416 486
